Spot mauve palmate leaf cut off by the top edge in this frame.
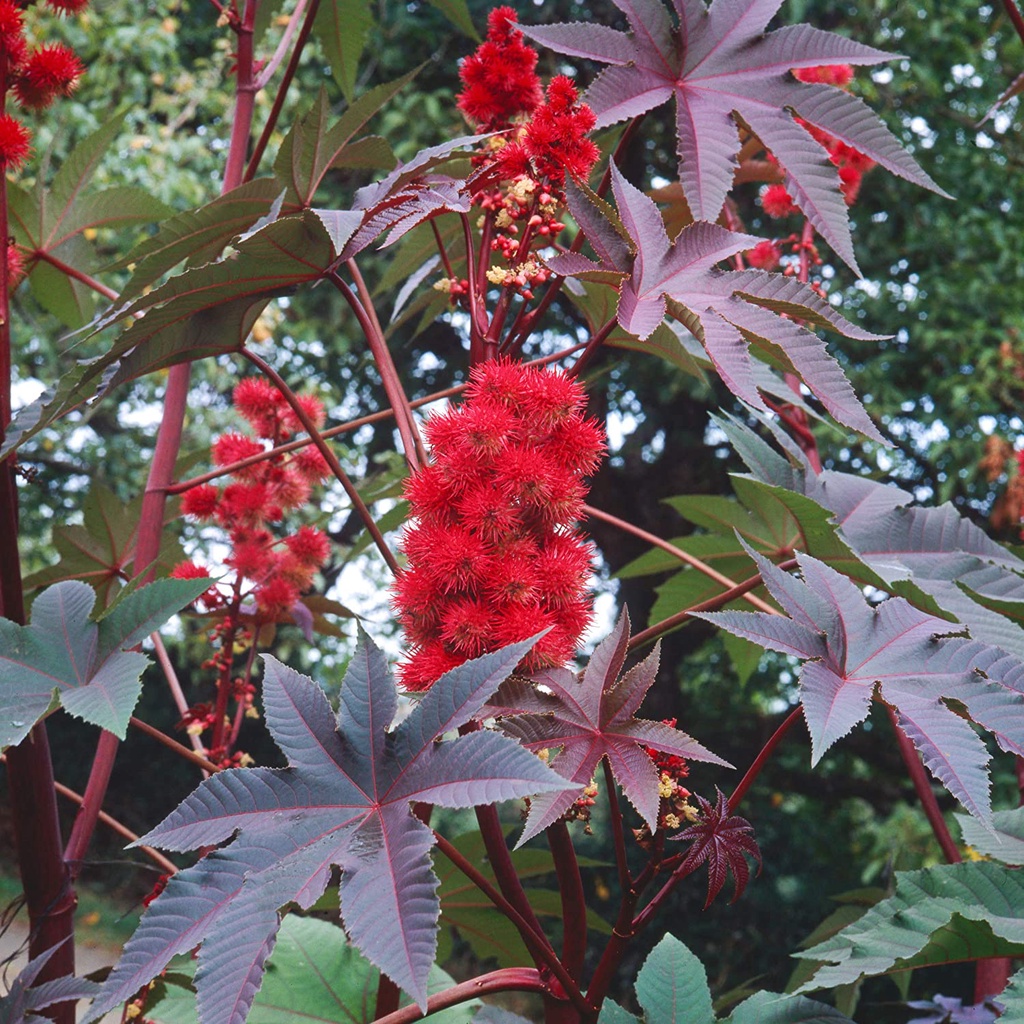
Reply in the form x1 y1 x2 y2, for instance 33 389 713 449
522 0 944 272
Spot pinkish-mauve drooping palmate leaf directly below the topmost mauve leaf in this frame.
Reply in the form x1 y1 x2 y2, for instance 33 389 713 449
548 165 885 443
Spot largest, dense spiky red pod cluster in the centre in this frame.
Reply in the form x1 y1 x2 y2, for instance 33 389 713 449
394 360 604 690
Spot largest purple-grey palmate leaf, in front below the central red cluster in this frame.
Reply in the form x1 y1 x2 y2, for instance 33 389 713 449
91 636 565 1024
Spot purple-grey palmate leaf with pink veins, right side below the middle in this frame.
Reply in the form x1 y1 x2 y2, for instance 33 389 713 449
698 549 1024 822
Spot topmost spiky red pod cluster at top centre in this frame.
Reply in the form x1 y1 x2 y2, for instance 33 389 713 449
459 7 541 131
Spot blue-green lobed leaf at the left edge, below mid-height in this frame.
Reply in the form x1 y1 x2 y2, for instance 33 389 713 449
0 580 209 748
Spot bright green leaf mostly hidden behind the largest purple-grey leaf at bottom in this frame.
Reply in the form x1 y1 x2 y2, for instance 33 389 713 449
146 914 481 1024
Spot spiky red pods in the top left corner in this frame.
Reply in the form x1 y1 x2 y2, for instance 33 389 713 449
0 0 88 165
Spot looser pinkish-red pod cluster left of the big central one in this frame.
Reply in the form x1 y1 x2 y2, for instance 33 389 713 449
173 377 330 621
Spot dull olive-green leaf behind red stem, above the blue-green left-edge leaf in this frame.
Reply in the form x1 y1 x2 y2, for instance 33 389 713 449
24 483 183 608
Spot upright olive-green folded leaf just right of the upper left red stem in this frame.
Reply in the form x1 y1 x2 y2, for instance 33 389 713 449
273 71 419 207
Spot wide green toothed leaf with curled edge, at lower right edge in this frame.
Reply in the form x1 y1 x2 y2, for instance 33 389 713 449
795 861 1024 992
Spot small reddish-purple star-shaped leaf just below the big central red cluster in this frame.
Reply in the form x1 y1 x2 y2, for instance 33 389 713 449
489 611 732 846
